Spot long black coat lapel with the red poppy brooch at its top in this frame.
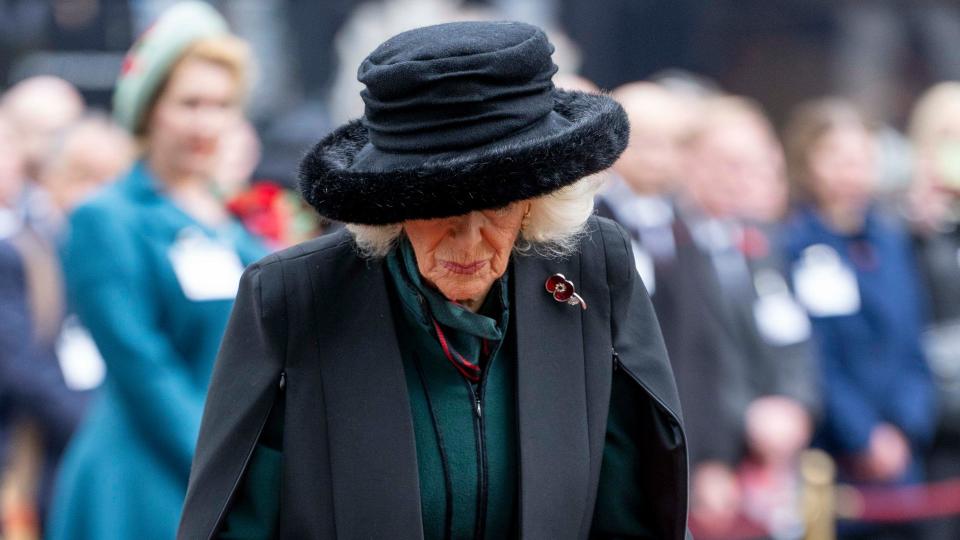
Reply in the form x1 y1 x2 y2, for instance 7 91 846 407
513 256 590 539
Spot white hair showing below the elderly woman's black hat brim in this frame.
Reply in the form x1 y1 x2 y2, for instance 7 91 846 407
346 173 605 258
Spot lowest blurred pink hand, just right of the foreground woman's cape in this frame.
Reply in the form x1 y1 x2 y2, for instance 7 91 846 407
690 462 740 535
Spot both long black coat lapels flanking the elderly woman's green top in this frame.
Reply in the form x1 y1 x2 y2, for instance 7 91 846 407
314 244 590 539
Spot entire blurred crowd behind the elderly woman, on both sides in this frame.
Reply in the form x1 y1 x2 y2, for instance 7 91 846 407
0 2 960 539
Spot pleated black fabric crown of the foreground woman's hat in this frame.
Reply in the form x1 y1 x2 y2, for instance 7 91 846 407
357 22 557 153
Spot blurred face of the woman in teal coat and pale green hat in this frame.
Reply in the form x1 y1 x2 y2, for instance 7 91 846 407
147 59 240 176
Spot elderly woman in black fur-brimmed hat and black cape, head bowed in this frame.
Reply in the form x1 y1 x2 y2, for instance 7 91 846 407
179 22 687 539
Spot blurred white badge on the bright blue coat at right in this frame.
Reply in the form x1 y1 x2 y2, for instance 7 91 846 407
793 244 860 317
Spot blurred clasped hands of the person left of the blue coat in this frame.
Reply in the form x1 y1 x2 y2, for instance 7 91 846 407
746 396 813 466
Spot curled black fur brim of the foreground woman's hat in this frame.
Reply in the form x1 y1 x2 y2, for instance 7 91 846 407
300 90 630 225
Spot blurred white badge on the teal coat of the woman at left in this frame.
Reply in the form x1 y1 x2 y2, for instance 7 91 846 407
169 229 243 301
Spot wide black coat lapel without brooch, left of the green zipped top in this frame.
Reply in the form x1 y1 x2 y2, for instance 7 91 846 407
298 257 423 539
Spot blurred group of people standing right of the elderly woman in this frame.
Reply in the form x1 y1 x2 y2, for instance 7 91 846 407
598 77 960 538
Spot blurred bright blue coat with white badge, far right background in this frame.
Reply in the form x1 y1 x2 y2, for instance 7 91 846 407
786 208 936 480
